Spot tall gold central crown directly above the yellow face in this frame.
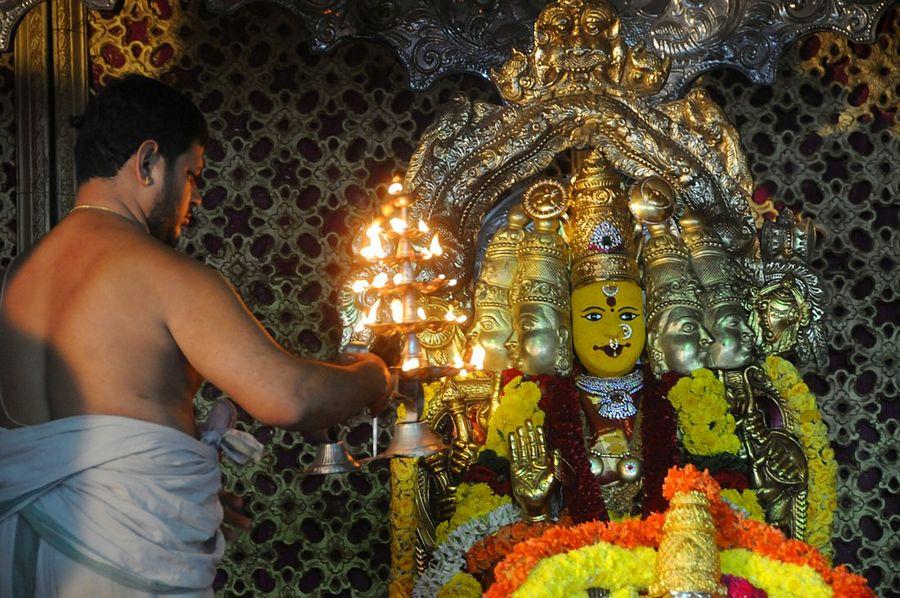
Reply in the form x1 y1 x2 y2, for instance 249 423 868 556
569 151 640 289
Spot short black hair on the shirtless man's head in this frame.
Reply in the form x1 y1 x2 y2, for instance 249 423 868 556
72 74 208 185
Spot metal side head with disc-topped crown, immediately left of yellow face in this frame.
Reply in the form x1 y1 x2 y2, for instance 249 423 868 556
508 179 572 375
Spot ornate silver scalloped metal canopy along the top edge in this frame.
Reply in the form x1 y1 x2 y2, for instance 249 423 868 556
0 0 892 99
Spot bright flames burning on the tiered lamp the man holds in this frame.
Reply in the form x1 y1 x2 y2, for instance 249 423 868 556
351 182 485 376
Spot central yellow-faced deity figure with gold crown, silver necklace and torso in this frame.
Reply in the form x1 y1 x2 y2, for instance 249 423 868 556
569 150 646 514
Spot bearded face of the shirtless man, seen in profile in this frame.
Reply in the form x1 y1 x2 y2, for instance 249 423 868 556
147 144 204 247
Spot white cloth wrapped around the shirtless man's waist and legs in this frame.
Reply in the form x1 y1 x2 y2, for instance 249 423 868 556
0 415 225 597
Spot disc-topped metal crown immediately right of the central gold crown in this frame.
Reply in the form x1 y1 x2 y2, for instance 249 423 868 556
629 177 703 322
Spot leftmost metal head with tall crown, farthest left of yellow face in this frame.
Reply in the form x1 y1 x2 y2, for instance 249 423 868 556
469 206 528 372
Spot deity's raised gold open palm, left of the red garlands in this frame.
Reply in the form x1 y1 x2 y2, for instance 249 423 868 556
507 419 561 522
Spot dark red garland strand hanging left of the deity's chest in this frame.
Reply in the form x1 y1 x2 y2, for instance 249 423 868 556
529 375 609 523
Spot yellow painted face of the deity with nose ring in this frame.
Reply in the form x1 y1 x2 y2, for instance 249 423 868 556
572 281 647 378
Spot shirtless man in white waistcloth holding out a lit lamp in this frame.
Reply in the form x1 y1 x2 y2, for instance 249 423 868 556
0 76 390 596
